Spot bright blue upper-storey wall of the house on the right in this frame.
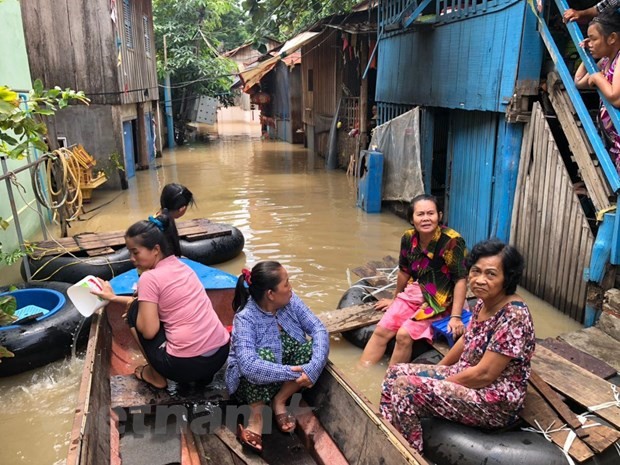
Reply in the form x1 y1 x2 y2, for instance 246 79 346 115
376 0 524 112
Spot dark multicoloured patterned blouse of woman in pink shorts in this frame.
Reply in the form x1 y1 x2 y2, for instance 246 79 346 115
398 226 467 316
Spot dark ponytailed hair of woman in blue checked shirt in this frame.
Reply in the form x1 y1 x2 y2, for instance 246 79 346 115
233 261 282 312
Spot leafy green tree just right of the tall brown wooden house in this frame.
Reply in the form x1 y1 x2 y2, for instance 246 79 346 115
153 0 241 114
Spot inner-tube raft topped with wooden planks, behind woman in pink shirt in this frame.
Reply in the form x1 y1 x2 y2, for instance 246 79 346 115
21 218 245 283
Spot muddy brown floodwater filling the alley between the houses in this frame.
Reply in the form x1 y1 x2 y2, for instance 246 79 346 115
0 114 579 464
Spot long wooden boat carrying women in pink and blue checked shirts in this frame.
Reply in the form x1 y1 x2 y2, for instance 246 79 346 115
66 266 427 465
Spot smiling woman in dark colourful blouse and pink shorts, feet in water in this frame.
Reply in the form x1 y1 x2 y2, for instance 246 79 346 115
360 194 467 365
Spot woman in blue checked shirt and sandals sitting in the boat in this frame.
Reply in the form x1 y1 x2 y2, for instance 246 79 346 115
226 261 329 452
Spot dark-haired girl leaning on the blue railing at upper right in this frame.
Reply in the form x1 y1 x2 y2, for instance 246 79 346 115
575 10 620 172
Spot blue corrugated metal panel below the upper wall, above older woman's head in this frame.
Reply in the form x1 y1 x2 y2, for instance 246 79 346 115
446 110 500 247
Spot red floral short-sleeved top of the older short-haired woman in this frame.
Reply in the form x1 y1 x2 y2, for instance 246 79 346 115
450 300 536 406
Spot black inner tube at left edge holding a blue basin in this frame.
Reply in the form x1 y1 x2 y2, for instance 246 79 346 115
0 282 90 377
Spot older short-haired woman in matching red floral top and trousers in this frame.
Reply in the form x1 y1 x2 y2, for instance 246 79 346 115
381 240 535 452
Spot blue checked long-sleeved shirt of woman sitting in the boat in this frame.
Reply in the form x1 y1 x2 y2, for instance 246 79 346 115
226 293 329 394
